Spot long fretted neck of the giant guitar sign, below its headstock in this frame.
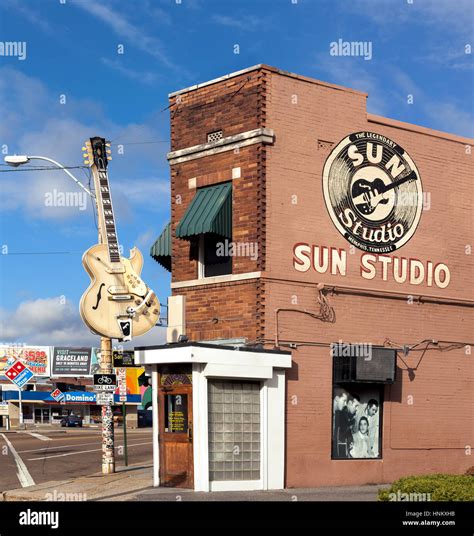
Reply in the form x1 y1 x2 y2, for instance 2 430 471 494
93 167 120 263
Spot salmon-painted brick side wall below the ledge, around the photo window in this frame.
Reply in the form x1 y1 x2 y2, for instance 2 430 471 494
265 282 474 487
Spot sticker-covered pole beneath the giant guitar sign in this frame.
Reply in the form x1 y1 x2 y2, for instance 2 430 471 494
99 340 115 475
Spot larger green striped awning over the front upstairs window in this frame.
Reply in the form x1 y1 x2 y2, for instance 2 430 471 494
176 182 232 239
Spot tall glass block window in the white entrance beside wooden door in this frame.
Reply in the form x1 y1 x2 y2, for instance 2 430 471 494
208 381 261 481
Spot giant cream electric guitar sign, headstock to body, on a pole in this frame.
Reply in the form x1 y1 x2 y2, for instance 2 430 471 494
80 137 160 341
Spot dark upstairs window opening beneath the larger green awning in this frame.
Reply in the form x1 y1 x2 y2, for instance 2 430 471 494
198 234 232 279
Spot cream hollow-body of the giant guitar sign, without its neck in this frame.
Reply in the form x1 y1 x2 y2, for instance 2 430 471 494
80 244 160 340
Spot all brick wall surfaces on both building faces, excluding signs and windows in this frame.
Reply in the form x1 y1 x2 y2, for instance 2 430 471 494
165 65 474 487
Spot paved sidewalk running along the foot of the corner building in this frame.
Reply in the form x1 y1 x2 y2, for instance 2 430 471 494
0 464 386 502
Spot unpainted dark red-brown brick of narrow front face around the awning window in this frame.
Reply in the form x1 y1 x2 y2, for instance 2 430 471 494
170 71 266 341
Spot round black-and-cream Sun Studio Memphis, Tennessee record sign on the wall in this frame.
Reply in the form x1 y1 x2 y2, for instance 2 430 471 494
323 132 423 253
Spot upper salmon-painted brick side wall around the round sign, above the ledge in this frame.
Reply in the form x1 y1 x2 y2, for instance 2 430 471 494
266 70 474 299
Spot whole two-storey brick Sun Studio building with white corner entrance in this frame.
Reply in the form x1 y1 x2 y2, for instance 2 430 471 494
138 65 474 489
